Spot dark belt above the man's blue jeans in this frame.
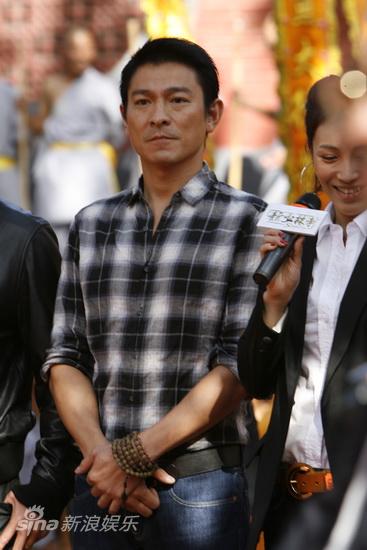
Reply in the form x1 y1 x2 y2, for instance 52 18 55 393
158 445 242 479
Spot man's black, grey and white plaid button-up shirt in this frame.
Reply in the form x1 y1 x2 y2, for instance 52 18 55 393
44 165 265 448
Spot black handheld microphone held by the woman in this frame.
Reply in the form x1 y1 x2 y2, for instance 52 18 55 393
253 193 321 288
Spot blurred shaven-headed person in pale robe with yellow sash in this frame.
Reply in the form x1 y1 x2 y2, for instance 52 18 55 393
32 27 123 248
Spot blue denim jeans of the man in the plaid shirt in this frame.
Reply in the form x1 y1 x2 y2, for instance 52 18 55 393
148 469 248 550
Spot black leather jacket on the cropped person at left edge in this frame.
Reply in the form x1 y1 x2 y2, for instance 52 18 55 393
0 201 78 517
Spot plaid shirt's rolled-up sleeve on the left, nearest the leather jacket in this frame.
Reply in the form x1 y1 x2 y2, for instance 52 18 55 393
42 222 94 379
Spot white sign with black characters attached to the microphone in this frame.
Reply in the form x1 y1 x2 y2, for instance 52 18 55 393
257 204 327 235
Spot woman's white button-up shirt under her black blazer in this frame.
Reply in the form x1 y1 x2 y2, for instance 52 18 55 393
283 204 367 468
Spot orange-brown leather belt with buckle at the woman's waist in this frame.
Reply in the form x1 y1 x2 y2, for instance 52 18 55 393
280 462 333 500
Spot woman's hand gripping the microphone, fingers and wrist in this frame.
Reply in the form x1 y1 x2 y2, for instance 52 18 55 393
260 229 304 328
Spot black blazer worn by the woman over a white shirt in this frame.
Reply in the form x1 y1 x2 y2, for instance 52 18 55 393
238 238 367 549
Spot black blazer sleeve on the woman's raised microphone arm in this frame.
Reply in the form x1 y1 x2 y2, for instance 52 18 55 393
238 291 286 399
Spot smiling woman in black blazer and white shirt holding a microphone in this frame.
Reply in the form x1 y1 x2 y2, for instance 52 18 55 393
238 76 367 550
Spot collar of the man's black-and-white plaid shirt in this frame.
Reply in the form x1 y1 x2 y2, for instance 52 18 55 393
128 162 217 206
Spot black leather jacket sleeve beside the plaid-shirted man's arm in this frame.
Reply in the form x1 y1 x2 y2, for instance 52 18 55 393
14 224 79 518
